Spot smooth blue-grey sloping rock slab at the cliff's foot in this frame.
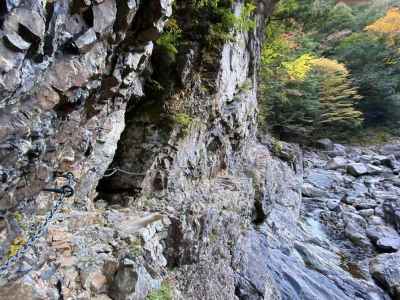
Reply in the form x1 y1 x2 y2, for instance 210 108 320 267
231 231 387 300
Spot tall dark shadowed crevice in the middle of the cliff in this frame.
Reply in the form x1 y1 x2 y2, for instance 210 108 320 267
97 42 177 201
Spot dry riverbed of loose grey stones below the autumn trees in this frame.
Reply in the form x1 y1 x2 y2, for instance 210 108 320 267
302 140 400 299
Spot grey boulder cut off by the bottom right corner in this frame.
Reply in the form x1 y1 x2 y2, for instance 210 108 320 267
369 253 400 299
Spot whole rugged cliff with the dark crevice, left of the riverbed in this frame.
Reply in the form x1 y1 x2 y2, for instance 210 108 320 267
0 0 284 299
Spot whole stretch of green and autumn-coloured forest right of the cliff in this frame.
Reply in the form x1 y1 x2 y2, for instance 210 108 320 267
260 0 400 141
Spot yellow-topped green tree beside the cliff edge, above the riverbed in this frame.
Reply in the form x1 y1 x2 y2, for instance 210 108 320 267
261 23 362 137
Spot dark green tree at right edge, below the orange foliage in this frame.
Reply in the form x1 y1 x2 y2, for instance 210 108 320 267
335 32 400 126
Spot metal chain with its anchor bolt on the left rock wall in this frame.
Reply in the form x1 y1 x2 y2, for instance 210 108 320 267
0 173 75 277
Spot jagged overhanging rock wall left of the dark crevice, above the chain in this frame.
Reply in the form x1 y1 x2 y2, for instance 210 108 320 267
0 0 171 209
